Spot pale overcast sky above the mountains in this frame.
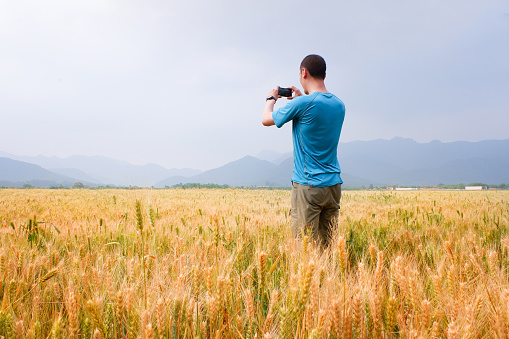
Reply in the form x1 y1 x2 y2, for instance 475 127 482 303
0 0 509 169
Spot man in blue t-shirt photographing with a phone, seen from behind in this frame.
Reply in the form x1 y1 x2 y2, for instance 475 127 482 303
262 54 345 246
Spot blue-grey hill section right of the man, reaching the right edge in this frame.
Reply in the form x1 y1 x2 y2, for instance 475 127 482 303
338 138 509 185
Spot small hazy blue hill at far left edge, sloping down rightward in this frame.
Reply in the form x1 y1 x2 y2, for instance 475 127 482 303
0 157 82 187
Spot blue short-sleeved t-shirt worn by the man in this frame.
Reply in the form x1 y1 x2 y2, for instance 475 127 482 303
272 92 345 187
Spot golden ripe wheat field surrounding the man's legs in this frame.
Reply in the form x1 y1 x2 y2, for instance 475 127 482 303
0 189 509 338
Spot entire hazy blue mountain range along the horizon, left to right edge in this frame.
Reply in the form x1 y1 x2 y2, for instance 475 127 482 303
0 138 509 187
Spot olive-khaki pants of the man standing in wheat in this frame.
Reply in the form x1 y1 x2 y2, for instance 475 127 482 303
290 182 341 246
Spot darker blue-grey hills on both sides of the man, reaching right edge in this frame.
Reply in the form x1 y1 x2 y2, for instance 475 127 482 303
177 138 509 187
